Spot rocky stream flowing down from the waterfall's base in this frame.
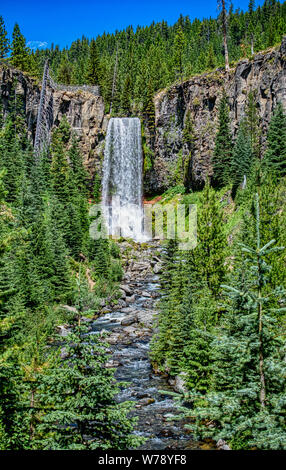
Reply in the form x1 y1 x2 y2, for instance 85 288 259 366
90 242 202 450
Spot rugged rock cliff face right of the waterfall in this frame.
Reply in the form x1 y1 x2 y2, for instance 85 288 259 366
149 38 286 193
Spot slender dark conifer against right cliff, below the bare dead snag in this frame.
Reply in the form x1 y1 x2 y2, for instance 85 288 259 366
212 91 232 187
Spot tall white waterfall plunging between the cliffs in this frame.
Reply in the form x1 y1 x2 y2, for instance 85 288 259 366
102 118 144 241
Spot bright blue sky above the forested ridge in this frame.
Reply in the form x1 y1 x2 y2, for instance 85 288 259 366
0 0 263 47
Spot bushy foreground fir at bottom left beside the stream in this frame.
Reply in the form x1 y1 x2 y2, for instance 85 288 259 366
35 326 141 450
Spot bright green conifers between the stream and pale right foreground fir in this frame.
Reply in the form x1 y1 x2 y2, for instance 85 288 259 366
151 184 226 384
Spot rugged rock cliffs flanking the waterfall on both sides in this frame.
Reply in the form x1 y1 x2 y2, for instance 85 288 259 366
0 38 286 194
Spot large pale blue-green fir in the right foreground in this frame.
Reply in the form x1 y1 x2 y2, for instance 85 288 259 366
181 196 286 449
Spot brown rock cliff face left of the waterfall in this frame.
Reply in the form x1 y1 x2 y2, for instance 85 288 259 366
0 65 107 174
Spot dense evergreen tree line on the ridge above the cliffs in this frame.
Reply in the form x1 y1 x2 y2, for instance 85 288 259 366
0 0 286 115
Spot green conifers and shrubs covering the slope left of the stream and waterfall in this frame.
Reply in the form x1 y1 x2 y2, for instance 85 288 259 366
0 95 128 450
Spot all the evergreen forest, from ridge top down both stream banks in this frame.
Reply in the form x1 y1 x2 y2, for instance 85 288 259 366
0 0 286 451
